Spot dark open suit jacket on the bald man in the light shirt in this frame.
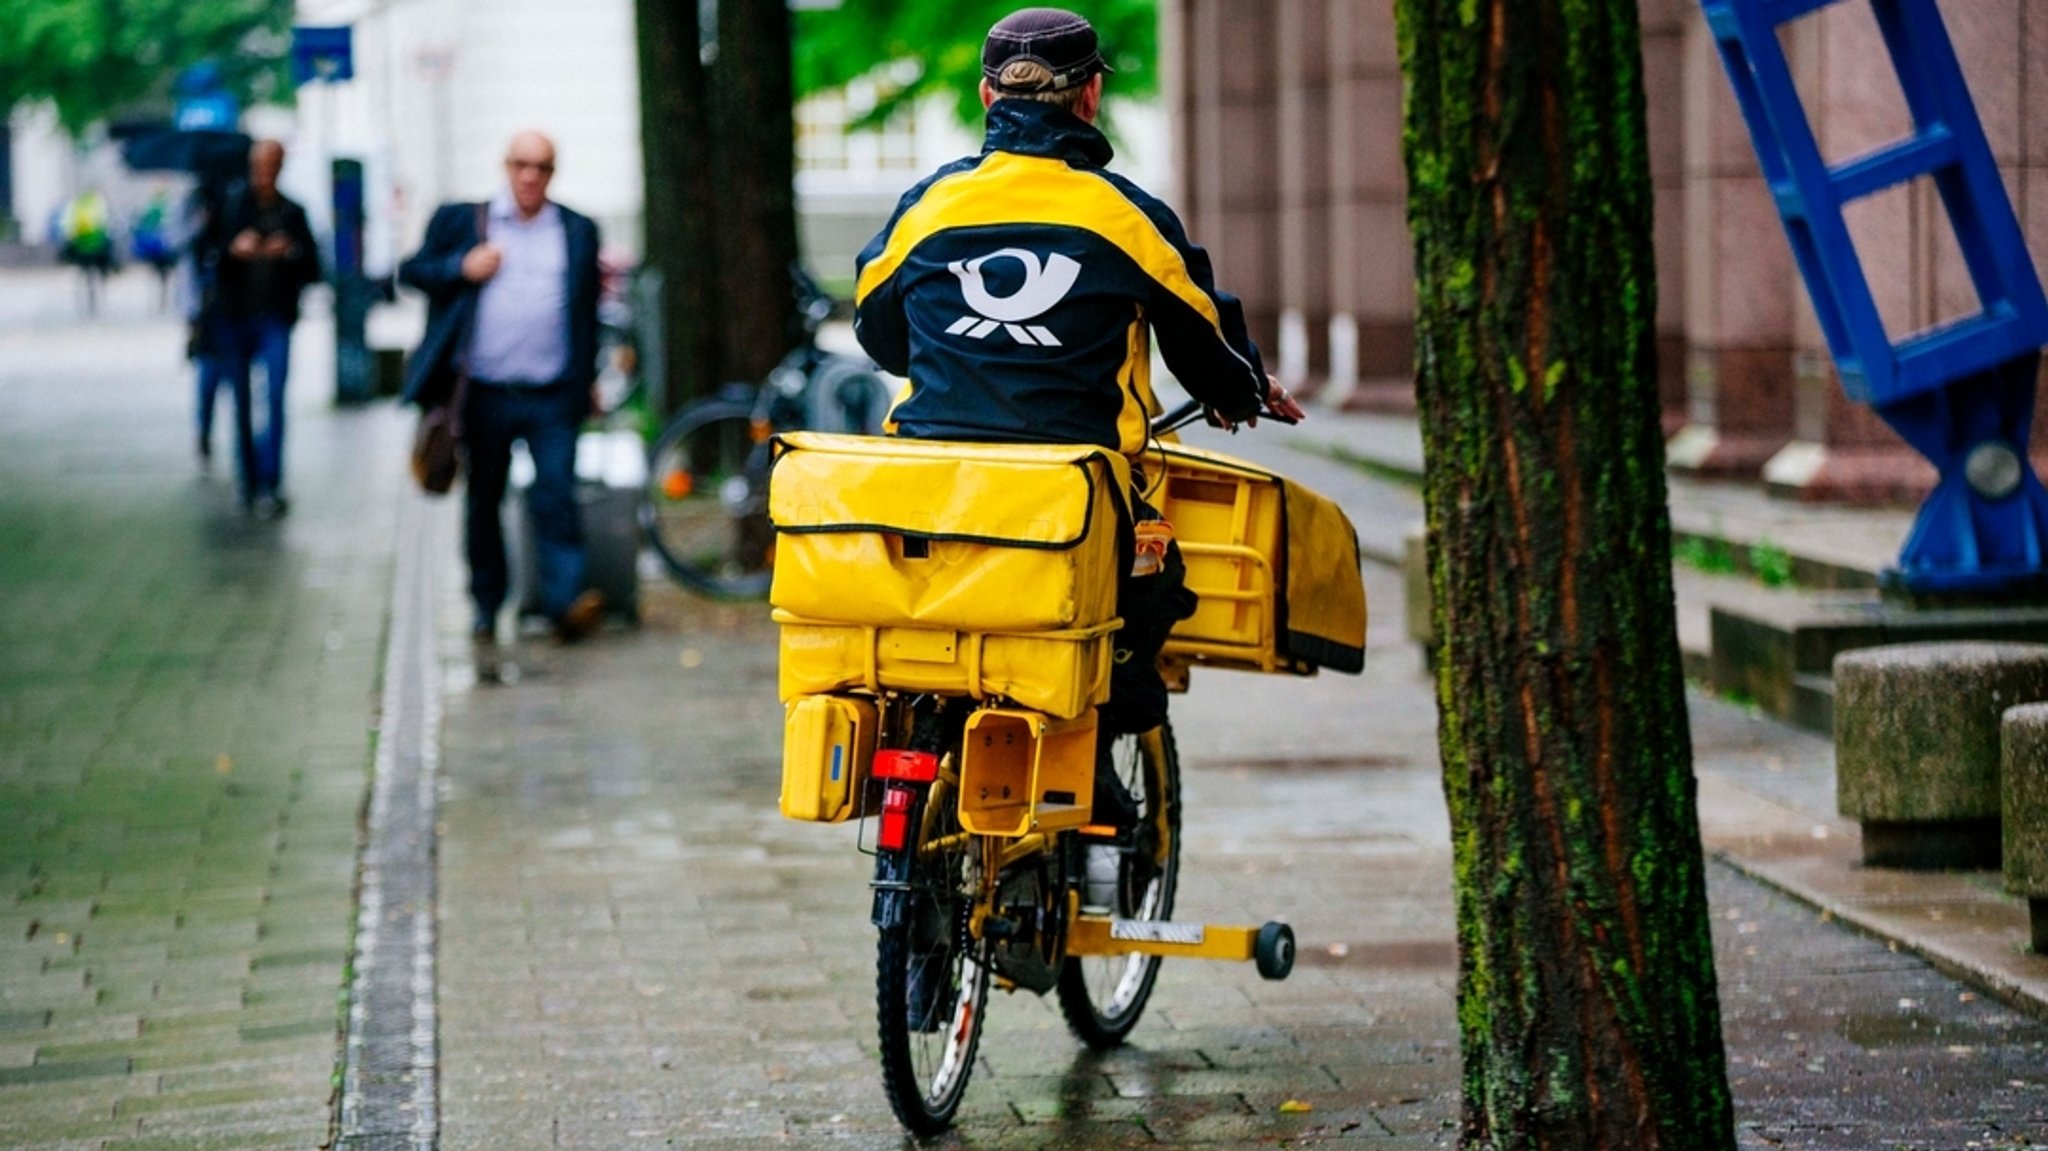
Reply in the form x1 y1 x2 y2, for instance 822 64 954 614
397 203 600 408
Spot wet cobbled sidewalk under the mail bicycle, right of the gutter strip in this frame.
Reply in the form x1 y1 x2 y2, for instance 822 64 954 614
440 565 2048 1151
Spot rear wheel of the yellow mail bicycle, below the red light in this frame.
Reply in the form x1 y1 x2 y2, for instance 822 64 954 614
874 782 989 1135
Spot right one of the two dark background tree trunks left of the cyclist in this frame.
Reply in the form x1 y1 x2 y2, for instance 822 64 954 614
713 0 797 381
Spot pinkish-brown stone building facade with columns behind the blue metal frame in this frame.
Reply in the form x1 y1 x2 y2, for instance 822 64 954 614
1161 0 2048 500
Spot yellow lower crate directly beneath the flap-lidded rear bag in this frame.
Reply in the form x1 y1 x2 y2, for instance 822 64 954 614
774 610 1122 719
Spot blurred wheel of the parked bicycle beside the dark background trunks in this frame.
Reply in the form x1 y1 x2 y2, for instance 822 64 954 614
641 399 774 600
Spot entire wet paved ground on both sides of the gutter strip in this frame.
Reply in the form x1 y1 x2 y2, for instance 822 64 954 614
0 270 2048 1151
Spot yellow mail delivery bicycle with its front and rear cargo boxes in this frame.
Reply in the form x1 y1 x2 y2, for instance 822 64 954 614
770 393 1366 1135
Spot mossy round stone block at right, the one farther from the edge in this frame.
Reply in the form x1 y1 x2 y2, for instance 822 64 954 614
1835 643 2048 868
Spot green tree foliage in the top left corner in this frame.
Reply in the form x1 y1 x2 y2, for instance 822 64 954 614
0 0 293 133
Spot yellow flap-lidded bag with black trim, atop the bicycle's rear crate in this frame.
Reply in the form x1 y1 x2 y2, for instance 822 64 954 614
768 432 1130 633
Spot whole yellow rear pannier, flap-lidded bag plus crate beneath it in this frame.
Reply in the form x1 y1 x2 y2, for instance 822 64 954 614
768 432 1128 719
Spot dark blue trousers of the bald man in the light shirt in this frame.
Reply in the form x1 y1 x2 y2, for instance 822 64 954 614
463 383 586 629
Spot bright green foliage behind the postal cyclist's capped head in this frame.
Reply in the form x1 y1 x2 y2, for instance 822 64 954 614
795 0 1159 127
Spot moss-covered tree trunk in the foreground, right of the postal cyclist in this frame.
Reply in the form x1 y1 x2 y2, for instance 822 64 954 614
1395 0 1735 1151
